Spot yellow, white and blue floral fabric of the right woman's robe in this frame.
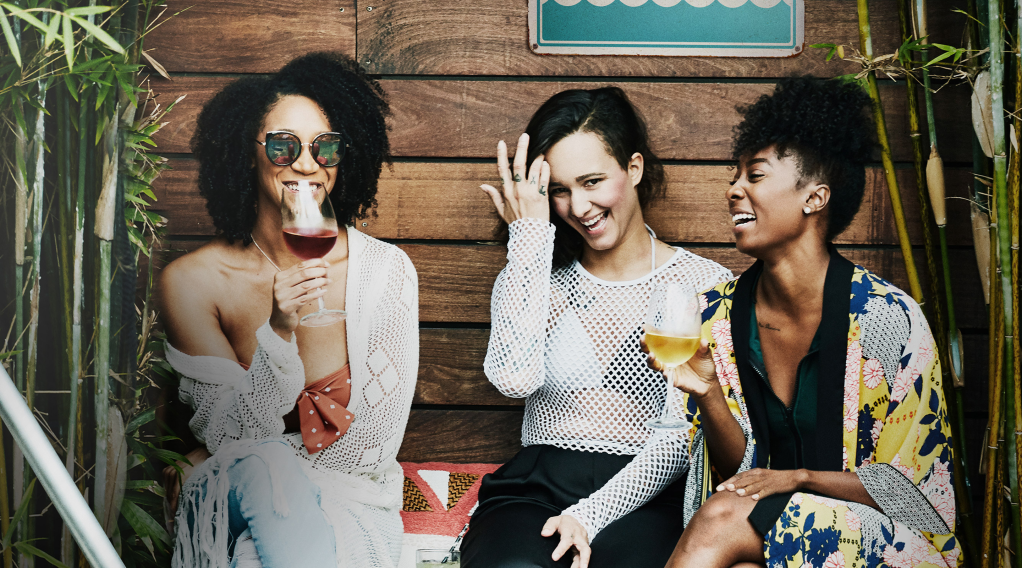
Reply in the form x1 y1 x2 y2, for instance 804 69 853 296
701 267 961 568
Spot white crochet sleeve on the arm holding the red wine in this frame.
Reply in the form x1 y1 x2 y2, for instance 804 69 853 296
168 321 306 454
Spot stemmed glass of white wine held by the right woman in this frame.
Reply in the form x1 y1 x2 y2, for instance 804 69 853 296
646 282 702 430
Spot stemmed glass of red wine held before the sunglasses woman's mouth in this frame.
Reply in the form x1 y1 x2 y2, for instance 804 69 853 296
280 181 347 327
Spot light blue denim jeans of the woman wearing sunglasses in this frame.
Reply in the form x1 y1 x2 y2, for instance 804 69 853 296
193 440 337 568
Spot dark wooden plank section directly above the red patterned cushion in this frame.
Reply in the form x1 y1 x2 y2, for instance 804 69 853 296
398 410 523 464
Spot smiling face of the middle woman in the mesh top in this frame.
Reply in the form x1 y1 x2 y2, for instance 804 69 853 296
546 132 643 250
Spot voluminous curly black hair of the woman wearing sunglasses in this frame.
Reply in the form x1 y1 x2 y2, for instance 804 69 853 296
191 53 390 244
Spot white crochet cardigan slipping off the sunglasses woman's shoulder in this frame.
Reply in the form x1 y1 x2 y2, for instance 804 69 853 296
167 227 419 568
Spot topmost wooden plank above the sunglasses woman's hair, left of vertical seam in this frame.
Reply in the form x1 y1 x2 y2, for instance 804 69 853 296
145 0 356 74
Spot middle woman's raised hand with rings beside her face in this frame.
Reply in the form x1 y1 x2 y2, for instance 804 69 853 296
479 134 550 225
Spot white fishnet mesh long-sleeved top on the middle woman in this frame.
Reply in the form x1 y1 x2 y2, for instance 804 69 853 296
484 219 732 541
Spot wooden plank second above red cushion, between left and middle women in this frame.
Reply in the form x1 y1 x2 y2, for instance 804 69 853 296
412 328 525 407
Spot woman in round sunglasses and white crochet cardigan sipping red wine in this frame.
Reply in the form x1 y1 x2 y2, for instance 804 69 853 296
160 53 418 568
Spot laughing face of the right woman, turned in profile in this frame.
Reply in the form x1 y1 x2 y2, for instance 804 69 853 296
728 146 830 258
